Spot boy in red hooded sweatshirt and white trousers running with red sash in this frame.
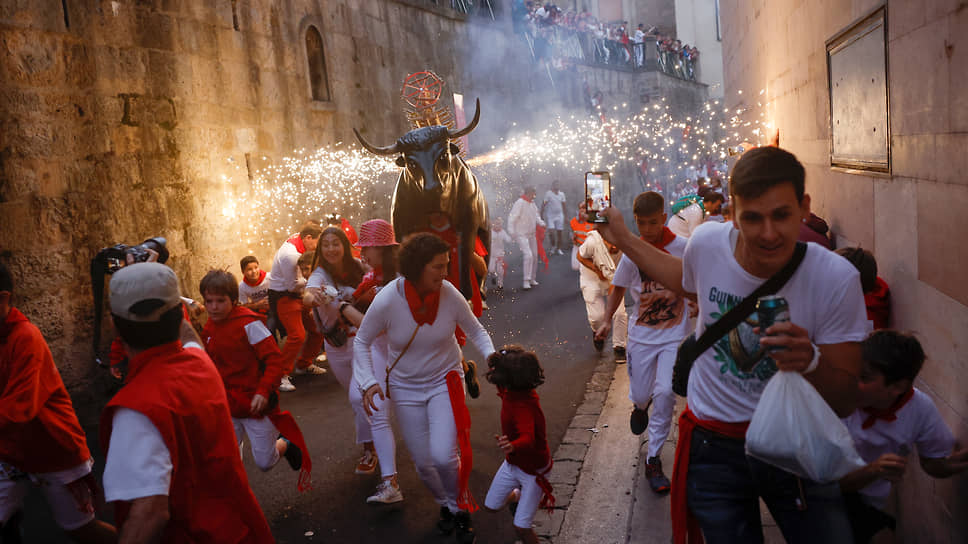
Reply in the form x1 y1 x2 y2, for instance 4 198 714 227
199 270 312 491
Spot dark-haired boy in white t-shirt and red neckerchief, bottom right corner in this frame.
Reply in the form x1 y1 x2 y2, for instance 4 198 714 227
840 330 968 544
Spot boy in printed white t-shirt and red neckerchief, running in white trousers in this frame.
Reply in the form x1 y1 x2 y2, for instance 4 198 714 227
595 191 690 493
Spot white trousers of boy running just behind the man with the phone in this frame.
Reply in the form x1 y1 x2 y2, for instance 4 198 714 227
627 342 679 457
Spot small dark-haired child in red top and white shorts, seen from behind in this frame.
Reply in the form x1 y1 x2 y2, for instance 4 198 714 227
484 346 555 544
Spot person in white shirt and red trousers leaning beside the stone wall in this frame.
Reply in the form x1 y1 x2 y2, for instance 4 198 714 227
268 223 323 391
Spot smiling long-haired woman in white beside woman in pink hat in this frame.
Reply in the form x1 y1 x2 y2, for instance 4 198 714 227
303 227 377 474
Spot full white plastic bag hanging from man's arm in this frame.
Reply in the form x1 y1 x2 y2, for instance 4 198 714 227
746 371 865 483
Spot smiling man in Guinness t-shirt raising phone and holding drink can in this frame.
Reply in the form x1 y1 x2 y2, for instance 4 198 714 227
599 147 868 542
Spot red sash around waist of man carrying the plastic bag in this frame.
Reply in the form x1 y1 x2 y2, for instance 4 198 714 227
671 404 750 544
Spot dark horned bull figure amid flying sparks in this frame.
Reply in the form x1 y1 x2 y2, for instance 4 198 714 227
353 99 491 299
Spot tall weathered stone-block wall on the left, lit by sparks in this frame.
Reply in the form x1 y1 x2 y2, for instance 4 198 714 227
0 0 548 416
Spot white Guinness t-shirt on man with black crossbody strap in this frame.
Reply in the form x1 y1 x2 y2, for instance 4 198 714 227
682 223 870 423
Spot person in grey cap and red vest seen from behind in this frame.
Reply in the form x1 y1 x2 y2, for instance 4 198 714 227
101 262 274 544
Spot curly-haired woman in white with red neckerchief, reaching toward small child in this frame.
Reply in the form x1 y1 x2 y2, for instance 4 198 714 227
353 233 494 544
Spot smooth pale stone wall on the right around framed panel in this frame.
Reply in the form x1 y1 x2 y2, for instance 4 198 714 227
722 0 968 542
